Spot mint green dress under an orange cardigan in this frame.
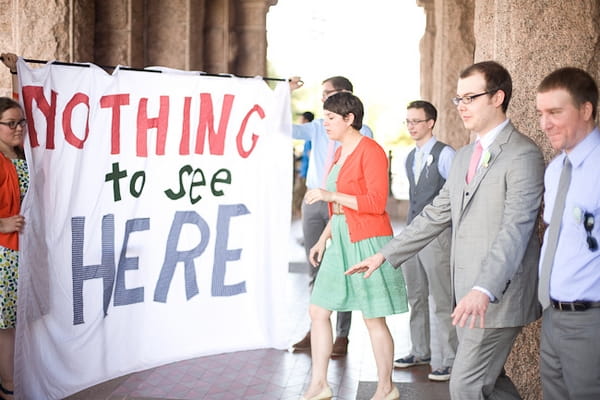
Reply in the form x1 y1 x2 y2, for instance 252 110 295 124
310 165 408 318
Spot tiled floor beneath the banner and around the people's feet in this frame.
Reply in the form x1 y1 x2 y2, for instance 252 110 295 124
67 217 449 400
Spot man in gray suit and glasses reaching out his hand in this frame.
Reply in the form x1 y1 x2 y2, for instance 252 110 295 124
347 61 544 400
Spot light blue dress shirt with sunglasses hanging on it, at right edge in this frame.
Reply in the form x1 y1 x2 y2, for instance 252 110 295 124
540 127 600 301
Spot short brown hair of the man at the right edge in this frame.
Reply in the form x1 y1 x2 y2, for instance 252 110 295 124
537 67 598 120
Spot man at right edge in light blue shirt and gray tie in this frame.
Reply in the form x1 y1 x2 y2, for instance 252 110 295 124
537 67 600 400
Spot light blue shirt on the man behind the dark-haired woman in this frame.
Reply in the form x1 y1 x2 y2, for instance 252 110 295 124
292 118 373 189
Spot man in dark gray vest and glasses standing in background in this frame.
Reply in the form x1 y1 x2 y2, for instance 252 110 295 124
394 100 458 381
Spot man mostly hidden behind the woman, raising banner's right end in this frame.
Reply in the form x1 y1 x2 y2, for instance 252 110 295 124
290 76 373 357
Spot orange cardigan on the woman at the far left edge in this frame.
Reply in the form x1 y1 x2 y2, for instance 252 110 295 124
0 153 21 250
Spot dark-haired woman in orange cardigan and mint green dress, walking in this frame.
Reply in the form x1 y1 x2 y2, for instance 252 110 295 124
302 92 408 400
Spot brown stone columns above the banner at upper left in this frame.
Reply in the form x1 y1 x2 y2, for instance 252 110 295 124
0 0 277 95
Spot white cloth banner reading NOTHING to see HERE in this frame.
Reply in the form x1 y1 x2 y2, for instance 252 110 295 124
15 59 292 399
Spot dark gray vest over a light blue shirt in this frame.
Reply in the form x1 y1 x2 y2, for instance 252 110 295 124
406 141 447 223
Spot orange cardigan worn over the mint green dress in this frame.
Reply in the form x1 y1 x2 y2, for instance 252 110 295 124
329 136 393 243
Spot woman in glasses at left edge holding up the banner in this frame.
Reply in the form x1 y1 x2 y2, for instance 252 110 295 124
0 53 29 399
